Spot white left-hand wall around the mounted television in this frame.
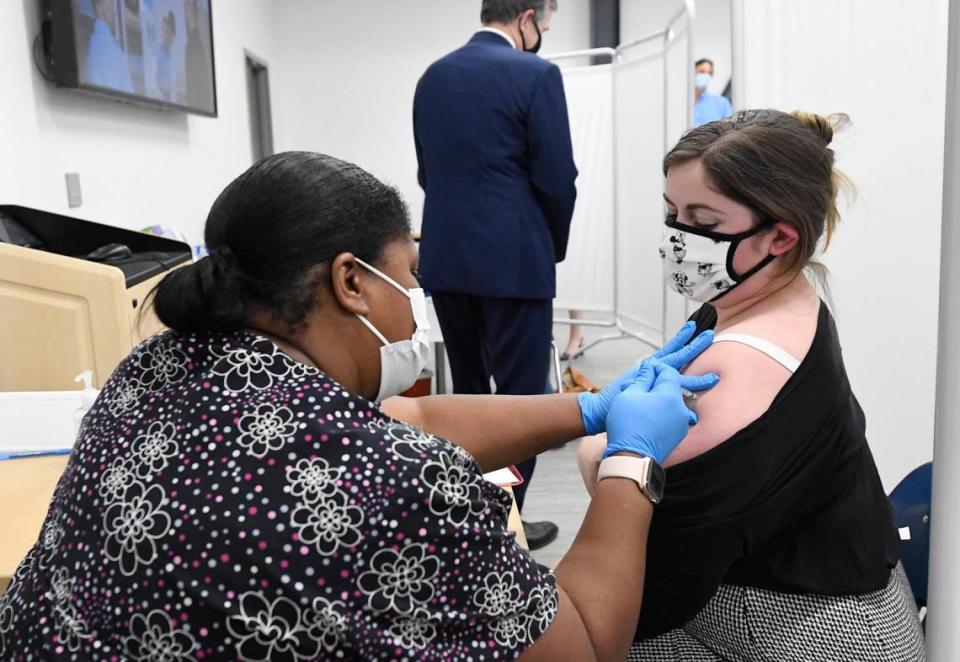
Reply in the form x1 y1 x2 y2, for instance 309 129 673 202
0 0 277 246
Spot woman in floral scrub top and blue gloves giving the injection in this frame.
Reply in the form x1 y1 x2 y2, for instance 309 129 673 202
0 153 716 660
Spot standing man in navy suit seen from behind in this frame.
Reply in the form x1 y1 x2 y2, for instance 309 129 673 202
413 0 577 548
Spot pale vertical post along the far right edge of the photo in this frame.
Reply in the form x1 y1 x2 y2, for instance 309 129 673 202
927 0 960 662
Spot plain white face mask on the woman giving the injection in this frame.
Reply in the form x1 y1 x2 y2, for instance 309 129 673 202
357 258 430 402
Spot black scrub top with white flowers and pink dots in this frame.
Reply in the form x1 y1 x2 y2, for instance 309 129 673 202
0 332 557 662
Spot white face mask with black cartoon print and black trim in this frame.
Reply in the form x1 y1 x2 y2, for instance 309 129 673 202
660 221 774 303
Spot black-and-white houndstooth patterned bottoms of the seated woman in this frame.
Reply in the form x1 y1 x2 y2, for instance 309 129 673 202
627 565 924 662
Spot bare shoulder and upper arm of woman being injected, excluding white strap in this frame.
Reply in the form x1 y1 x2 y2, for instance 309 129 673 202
665 298 819 466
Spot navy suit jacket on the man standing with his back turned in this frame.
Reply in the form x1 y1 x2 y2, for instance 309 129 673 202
413 32 577 299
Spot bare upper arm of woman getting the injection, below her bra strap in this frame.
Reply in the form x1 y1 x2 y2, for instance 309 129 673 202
664 343 790 466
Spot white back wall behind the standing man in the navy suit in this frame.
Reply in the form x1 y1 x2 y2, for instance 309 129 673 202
273 0 590 226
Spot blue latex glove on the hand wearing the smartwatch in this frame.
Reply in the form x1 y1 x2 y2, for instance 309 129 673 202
603 361 697 464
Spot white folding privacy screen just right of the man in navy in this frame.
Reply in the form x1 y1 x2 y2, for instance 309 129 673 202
551 10 693 347
